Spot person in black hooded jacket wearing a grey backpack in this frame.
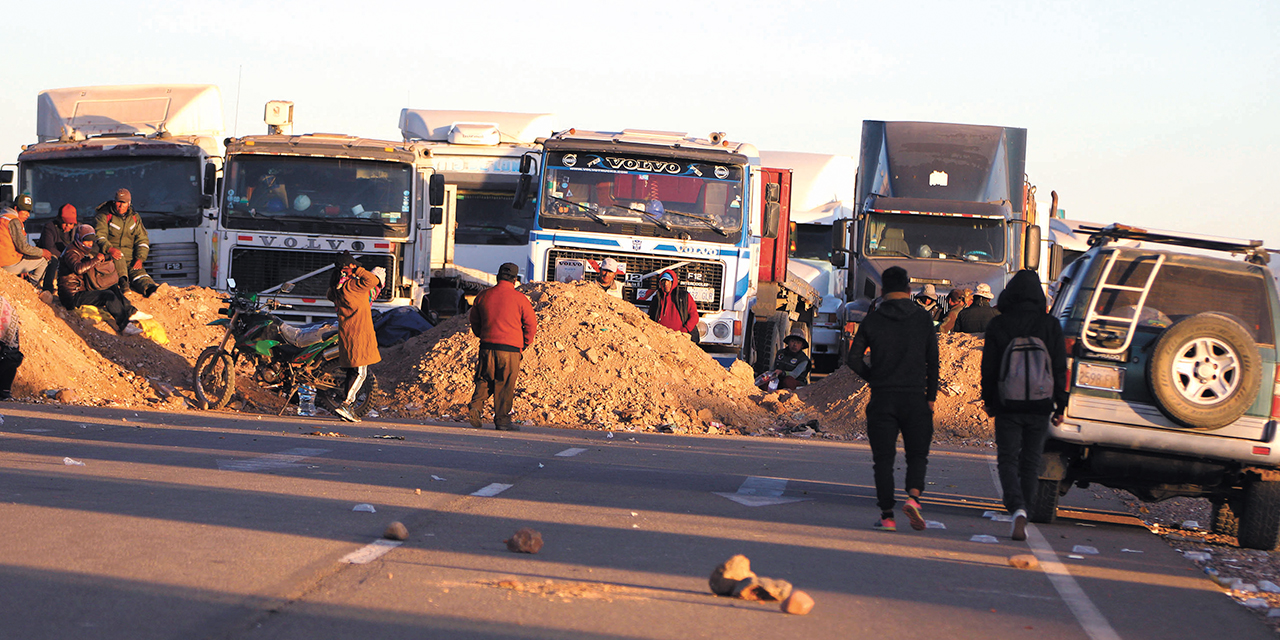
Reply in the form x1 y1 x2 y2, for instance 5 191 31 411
982 269 1068 540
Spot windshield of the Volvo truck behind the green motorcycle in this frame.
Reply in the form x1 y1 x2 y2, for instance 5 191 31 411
223 154 413 237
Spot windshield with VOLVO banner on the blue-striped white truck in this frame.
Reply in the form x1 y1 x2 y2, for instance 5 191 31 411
539 151 742 243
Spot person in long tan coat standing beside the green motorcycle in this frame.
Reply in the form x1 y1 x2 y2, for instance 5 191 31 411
329 251 383 422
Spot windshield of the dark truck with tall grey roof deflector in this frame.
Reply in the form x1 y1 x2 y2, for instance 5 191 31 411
863 214 1005 262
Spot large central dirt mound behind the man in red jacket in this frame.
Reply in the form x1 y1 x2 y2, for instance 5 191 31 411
374 282 814 433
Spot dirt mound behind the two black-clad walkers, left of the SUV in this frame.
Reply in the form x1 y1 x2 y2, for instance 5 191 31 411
799 333 995 444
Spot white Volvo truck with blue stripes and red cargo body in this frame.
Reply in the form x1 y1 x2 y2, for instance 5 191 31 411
516 129 820 366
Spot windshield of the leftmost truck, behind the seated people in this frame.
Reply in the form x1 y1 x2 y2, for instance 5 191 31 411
22 157 202 229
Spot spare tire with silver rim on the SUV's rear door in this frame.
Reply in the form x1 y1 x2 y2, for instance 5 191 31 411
1147 312 1262 429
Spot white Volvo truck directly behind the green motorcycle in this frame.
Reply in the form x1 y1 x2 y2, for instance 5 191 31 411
215 101 442 321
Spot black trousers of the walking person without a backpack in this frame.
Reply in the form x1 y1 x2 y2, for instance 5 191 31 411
867 389 933 512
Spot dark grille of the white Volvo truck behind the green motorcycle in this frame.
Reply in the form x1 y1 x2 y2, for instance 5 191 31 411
228 247 397 302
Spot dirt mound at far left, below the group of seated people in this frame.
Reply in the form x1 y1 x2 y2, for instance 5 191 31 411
0 271 221 408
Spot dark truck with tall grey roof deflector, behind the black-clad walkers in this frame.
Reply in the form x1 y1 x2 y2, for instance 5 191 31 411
832 120 1041 335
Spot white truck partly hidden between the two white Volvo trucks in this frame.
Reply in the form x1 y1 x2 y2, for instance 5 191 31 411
399 109 556 316
